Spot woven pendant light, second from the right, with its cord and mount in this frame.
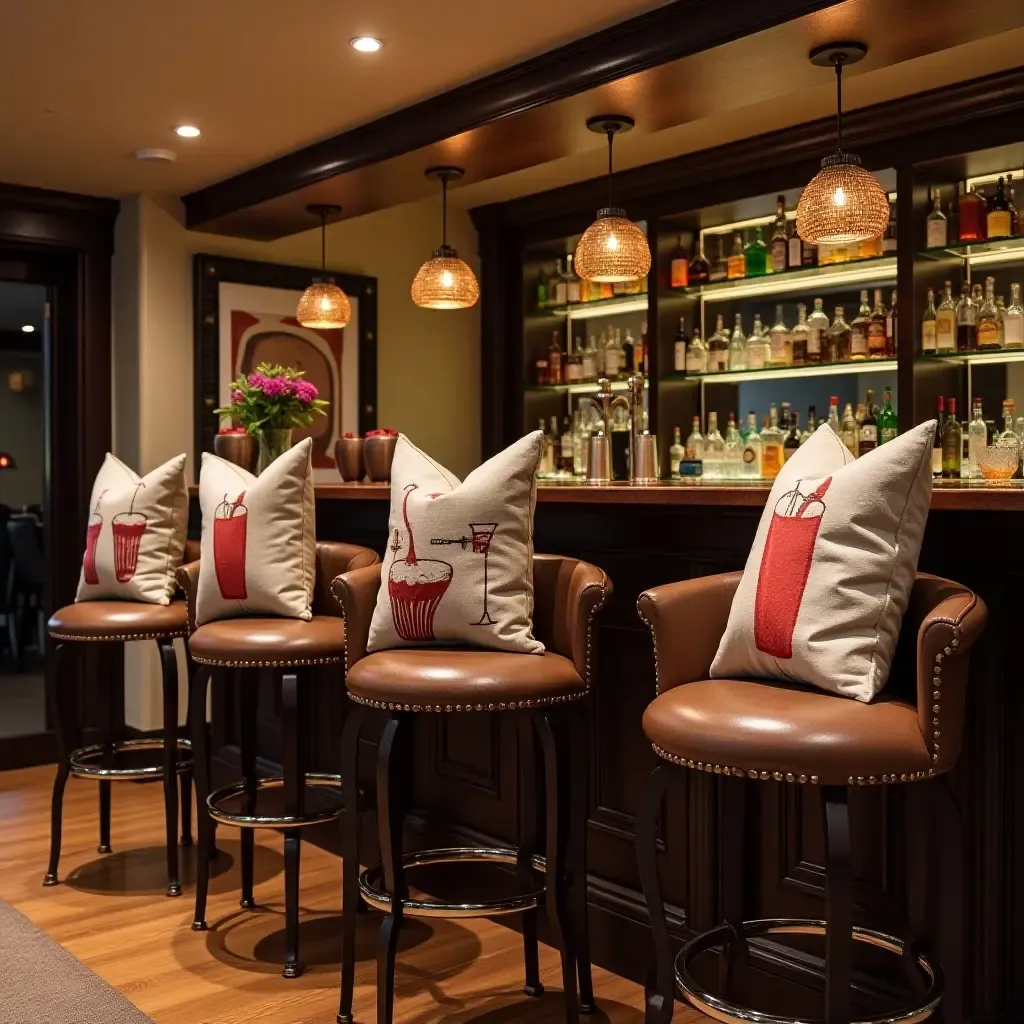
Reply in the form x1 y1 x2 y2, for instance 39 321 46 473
573 114 650 284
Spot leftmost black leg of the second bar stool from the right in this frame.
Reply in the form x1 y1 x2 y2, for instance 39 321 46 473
338 700 362 1024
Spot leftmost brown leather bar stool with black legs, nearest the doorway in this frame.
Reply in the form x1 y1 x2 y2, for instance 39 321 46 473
43 542 199 896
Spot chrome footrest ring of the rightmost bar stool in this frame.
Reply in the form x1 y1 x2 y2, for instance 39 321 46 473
676 918 943 1024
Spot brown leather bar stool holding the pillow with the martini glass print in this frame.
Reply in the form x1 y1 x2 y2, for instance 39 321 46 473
334 555 611 1024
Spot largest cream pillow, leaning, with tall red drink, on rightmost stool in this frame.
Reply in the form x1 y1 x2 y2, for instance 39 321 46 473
711 420 935 701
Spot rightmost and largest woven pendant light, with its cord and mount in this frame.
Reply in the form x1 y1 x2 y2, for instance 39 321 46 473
797 43 889 245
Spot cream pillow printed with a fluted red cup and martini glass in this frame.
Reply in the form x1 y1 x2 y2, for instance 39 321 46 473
367 430 544 654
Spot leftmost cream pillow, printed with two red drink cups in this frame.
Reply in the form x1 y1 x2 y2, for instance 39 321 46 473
75 453 188 604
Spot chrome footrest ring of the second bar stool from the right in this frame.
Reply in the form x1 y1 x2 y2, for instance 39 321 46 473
359 847 546 918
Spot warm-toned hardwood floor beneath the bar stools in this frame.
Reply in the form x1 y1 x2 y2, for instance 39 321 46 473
0 767 707 1024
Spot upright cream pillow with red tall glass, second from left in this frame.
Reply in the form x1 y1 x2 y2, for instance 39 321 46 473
196 437 316 626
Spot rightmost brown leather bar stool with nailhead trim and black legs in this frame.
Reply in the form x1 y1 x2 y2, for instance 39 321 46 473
637 572 987 1024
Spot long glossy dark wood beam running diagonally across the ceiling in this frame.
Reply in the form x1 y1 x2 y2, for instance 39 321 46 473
182 0 837 227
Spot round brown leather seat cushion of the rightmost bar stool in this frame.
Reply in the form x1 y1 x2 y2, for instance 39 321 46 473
643 679 931 785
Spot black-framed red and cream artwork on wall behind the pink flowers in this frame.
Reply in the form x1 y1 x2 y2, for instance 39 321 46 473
193 253 377 482
